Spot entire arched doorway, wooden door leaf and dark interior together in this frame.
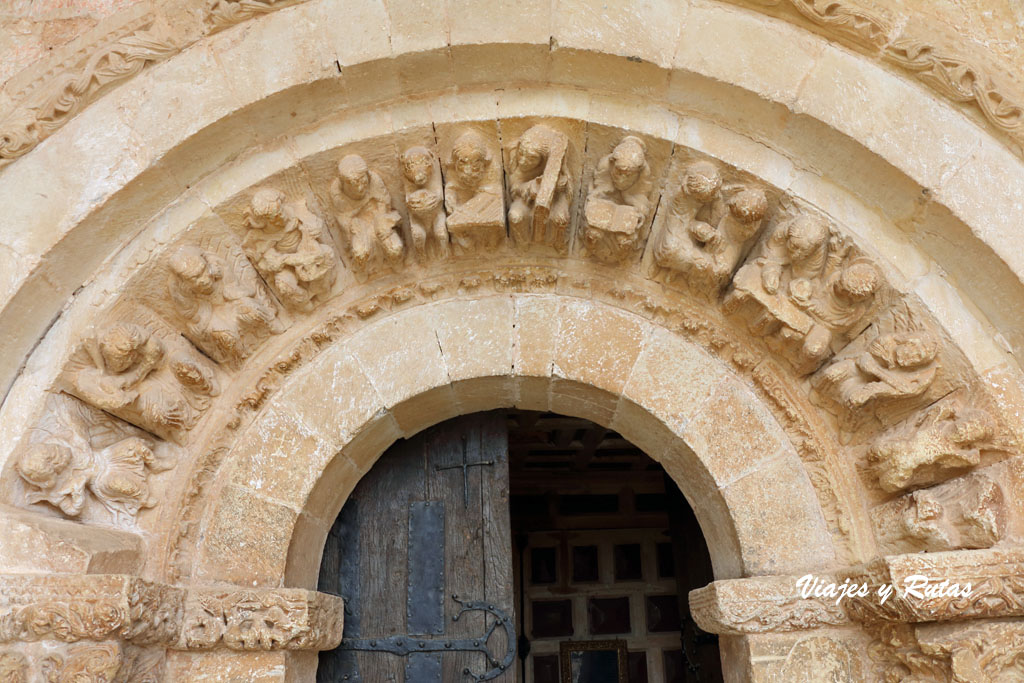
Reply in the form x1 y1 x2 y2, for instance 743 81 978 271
317 411 722 683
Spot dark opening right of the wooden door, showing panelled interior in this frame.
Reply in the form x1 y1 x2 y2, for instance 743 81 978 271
507 411 722 683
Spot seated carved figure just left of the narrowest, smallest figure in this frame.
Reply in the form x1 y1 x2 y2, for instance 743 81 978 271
331 155 406 274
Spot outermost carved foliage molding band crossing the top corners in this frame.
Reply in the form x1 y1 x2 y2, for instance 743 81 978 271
0 0 1024 169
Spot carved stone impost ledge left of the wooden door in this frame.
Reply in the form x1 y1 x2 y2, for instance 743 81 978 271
0 574 344 650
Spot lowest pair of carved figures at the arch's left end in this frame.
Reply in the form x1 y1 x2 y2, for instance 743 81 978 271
14 437 171 522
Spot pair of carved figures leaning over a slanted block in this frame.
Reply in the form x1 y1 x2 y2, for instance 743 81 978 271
724 215 881 375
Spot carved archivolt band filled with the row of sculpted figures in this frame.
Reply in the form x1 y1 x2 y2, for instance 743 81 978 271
2 112 1014 589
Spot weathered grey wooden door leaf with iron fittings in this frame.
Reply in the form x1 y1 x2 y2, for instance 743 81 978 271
316 413 516 683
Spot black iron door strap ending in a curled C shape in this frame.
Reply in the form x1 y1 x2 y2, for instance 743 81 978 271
340 595 516 681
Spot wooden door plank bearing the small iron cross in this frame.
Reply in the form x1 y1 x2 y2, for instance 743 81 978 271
427 416 487 681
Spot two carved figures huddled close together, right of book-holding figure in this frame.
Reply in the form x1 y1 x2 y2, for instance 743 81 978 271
654 161 768 296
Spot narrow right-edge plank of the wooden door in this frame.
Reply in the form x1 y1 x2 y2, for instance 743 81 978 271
475 413 520 683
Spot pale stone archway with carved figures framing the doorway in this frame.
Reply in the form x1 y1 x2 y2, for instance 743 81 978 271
0 0 1024 680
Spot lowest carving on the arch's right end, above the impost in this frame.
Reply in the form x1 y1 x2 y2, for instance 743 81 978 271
871 473 1007 553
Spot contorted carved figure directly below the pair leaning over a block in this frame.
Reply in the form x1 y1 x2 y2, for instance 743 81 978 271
817 331 939 411
